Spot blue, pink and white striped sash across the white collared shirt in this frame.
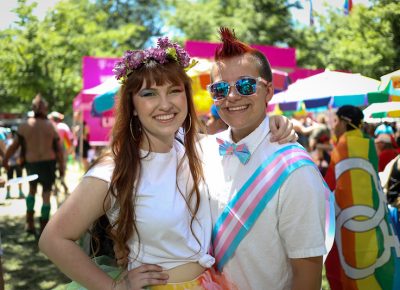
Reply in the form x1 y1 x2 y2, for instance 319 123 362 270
212 145 335 271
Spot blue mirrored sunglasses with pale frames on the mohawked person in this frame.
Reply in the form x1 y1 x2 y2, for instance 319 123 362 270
207 77 268 100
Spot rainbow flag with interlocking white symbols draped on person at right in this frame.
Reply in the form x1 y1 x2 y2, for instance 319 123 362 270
326 130 400 290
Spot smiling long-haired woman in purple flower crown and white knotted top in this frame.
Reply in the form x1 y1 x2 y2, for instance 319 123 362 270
39 38 291 290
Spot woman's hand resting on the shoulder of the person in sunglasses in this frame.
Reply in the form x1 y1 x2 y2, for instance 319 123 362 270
269 116 298 144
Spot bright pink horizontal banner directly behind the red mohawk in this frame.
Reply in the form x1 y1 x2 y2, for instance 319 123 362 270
185 40 296 68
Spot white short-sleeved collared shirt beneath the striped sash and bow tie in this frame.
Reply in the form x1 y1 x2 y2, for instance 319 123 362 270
201 117 326 290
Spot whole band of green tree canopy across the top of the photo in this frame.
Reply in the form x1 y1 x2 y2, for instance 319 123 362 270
0 0 400 113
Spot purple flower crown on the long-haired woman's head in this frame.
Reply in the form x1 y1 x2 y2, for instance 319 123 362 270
113 37 197 83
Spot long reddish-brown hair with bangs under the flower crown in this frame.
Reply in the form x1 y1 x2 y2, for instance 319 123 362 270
93 61 204 266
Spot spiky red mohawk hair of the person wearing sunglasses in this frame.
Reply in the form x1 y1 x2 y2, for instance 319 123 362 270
214 27 255 60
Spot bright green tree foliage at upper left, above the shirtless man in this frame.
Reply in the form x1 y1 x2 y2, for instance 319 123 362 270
0 0 144 112
